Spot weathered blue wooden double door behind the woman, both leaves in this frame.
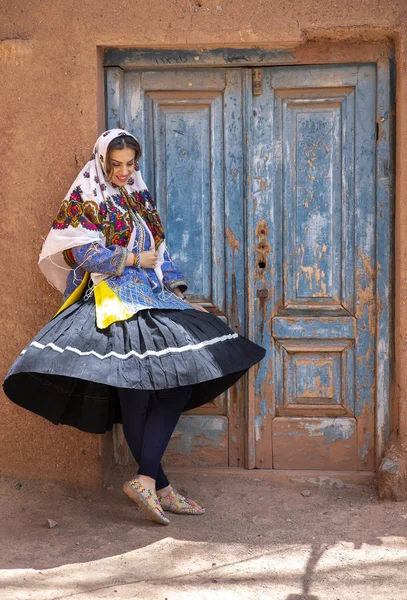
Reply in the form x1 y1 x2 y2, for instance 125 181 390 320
106 65 388 470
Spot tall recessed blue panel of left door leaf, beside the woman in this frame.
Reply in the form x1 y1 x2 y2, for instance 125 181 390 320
150 92 217 302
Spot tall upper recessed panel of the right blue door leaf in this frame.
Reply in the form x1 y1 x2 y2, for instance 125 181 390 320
275 87 355 314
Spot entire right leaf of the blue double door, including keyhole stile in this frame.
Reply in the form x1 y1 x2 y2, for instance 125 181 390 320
248 65 376 469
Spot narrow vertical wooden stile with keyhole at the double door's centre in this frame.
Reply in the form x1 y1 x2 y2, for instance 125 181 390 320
246 68 281 469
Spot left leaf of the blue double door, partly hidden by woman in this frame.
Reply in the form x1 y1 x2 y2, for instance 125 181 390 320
106 68 245 466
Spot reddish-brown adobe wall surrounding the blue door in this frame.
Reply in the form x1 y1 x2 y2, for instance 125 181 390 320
0 0 407 495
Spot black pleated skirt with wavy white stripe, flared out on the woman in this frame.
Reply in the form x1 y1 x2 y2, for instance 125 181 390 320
3 298 265 433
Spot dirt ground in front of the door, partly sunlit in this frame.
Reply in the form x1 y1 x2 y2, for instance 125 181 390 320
0 473 407 600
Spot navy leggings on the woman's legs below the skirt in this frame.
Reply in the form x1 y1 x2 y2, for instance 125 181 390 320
117 385 192 490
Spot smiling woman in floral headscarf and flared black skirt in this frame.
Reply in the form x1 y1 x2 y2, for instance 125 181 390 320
3 129 264 524
